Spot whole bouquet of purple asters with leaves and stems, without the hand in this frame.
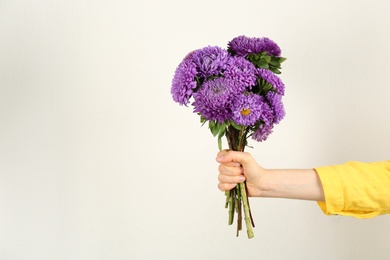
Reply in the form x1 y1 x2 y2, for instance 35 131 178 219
171 36 286 238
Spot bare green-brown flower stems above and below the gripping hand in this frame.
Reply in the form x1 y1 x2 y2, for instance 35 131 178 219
225 125 255 238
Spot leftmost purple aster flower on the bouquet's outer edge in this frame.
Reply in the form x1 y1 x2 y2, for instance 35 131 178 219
171 59 197 105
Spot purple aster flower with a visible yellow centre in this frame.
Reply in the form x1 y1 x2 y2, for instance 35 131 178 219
232 93 274 126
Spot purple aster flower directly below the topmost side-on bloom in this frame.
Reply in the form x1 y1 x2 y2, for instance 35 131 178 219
224 57 256 91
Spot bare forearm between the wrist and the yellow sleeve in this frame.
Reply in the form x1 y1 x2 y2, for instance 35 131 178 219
260 169 325 201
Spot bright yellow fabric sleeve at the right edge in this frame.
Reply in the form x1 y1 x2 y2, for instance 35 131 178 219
315 161 390 218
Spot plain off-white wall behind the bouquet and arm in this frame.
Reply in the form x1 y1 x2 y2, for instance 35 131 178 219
0 0 390 260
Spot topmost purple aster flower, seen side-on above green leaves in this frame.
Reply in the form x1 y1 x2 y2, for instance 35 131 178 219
228 35 281 57
